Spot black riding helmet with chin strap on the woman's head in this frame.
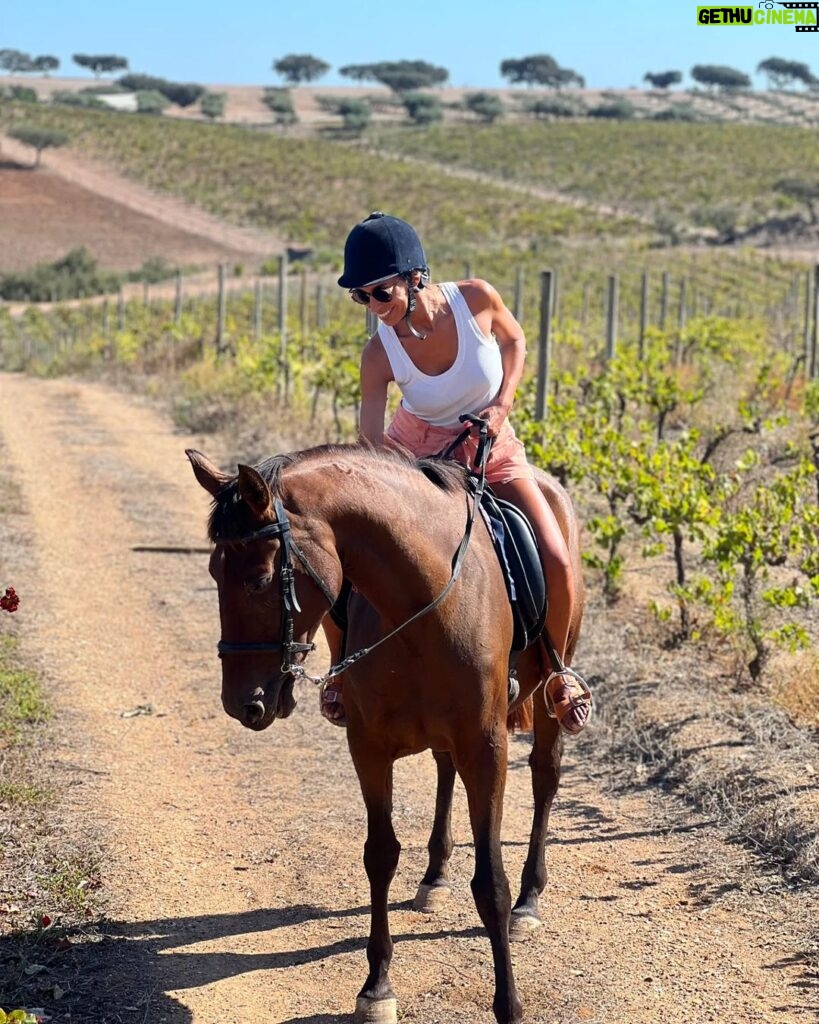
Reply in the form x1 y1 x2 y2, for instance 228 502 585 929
339 210 429 338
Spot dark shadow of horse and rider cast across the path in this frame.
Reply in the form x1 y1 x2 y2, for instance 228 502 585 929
0 901 483 1024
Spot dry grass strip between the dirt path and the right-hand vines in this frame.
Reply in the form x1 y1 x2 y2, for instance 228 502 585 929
581 609 819 884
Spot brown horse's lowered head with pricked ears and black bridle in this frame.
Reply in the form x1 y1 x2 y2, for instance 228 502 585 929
186 450 342 730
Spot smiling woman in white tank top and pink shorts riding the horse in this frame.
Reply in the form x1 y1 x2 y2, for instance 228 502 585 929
321 213 591 733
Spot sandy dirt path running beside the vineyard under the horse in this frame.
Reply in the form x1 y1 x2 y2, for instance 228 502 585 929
0 375 817 1024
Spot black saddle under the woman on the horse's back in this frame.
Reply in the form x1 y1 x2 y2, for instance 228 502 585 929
470 487 549 654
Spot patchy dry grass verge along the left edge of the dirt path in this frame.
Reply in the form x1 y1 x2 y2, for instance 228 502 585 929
0 466 101 1008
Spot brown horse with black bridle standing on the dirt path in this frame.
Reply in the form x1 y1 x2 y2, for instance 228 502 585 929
187 446 583 1024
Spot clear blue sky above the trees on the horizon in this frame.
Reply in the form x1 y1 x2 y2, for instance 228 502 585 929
6 0 819 88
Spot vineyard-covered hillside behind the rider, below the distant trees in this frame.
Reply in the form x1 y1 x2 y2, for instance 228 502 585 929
0 79 819 286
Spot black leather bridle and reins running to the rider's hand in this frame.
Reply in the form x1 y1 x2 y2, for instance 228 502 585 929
216 416 492 683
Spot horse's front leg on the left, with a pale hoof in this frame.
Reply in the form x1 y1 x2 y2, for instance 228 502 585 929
348 737 401 1024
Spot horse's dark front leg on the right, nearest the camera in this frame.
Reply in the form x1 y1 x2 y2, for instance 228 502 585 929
455 720 523 1024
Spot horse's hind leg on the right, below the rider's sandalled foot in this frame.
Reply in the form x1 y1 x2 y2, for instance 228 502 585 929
509 690 563 939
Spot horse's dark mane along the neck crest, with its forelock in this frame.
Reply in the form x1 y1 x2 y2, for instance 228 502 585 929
208 444 468 544
